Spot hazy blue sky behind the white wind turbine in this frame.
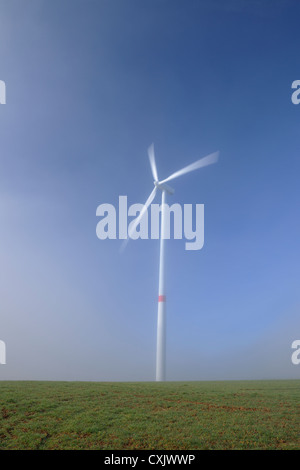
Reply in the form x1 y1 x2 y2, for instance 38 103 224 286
0 0 300 380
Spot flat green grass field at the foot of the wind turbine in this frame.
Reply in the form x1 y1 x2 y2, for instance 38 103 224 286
0 380 300 450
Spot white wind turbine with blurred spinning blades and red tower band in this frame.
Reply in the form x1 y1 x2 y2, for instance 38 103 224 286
125 144 219 382
